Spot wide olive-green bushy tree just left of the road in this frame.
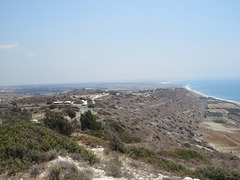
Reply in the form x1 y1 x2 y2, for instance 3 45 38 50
43 110 74 136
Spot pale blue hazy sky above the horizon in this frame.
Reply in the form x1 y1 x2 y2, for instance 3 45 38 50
0 0 240 85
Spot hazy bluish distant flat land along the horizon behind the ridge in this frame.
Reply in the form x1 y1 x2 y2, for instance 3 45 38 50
0 82 178 102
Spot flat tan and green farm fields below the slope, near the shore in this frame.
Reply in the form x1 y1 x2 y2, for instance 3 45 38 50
200 99 240 157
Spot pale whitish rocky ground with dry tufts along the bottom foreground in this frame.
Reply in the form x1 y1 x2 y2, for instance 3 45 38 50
9 144 198 180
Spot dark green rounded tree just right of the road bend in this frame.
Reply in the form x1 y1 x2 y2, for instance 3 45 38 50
80 111 102 131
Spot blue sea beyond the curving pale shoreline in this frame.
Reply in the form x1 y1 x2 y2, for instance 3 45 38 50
171 78 240 104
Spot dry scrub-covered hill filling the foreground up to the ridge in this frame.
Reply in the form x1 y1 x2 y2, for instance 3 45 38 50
0 89 240 179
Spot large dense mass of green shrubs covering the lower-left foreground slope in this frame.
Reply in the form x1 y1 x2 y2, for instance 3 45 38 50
0 120 98 174
